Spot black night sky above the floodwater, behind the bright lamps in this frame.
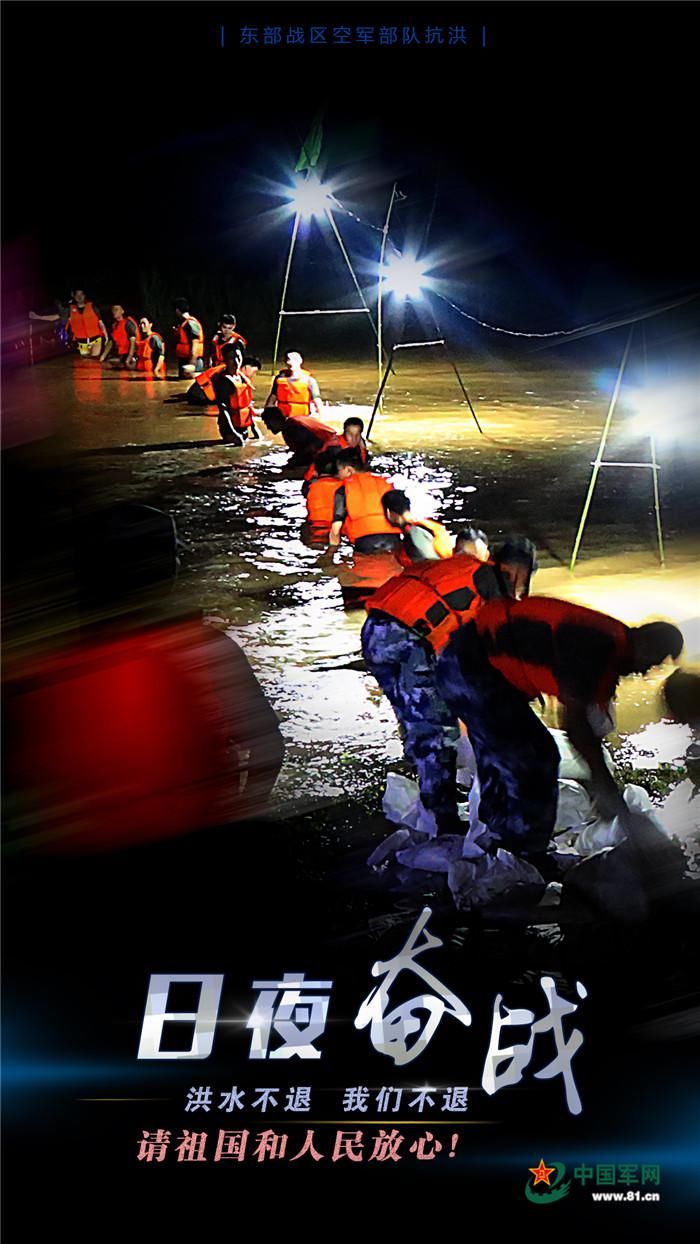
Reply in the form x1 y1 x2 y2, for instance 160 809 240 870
4 0 700 360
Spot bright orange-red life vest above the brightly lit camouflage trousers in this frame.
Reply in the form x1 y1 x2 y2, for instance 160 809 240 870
367 552 485 652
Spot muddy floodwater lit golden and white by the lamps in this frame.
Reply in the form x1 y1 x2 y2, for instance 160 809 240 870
5 358 700 811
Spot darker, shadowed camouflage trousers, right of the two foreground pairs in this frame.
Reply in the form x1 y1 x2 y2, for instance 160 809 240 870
436 631 560 856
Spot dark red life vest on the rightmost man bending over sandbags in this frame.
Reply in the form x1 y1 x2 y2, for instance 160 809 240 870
475 596 629 707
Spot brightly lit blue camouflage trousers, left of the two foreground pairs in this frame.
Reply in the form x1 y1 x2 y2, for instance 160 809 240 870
362 613 459 831
